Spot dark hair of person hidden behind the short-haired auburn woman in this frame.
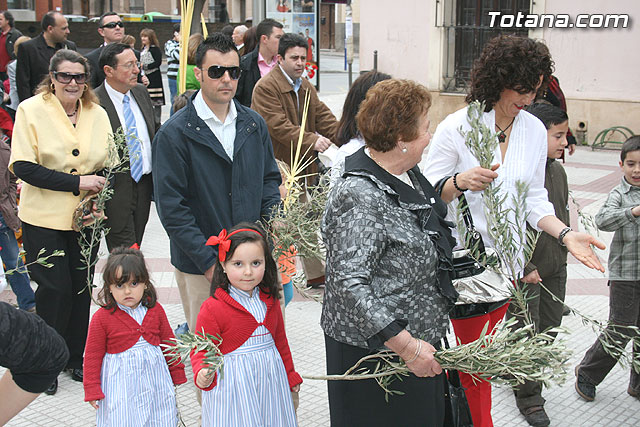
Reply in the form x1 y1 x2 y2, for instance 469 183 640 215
334 70 391 147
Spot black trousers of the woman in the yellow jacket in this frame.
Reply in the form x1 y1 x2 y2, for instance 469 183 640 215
22 223 98 369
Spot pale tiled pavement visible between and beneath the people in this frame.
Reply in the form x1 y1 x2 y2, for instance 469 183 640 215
0 72 640 427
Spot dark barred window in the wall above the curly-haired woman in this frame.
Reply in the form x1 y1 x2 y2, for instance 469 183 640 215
438 0 531 92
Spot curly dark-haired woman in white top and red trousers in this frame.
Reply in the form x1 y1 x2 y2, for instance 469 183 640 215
423 35 604 427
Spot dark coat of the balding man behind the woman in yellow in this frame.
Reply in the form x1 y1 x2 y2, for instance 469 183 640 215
16 33 76 102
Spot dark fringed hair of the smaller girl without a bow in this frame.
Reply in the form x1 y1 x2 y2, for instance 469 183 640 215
98 246 158 311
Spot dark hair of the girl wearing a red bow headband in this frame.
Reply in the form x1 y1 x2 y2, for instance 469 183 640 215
210 222 280 299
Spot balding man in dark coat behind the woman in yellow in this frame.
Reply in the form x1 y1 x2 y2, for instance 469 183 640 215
16 11 76 102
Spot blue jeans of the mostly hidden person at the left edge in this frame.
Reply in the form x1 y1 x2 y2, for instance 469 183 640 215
0 214 36 310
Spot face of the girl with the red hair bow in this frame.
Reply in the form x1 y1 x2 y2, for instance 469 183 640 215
223 242 265 292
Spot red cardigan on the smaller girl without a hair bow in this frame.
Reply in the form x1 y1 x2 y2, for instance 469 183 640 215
83 303 187 402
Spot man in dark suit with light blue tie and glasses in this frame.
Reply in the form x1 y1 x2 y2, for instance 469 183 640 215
95 43 157 251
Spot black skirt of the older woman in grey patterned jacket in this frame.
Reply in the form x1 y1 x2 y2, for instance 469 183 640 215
324 334 445 427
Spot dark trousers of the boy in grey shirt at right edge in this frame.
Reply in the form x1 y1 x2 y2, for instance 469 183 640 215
579 280 640 393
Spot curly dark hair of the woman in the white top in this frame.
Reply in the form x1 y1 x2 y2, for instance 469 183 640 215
466 35 553 112
